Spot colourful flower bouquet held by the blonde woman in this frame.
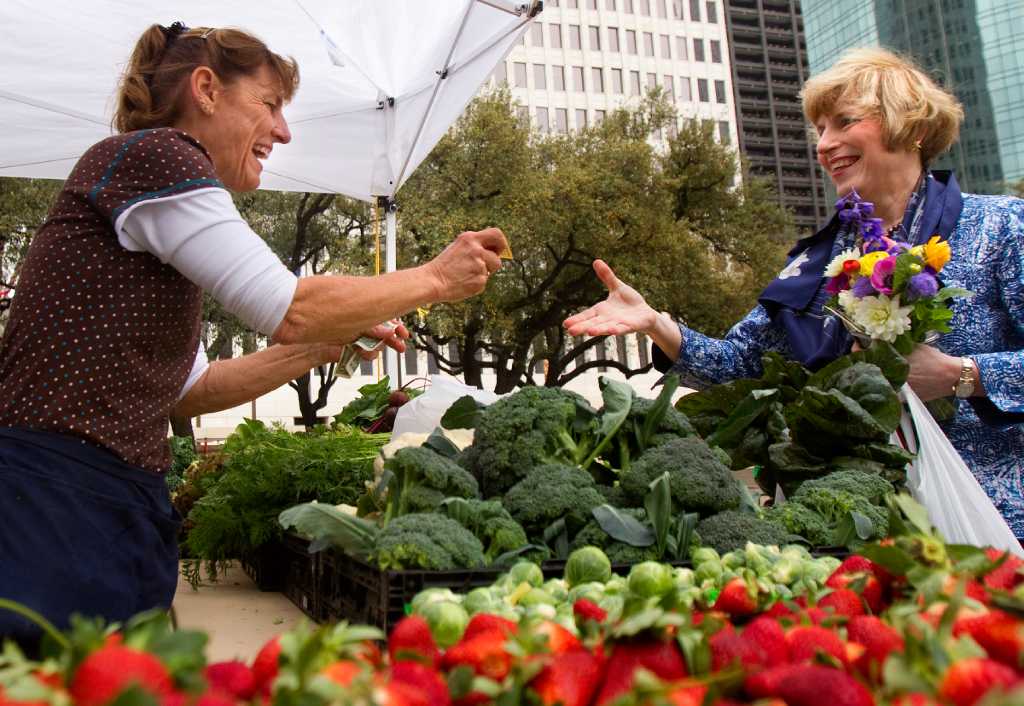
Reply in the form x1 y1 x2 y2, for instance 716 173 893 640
825 191 971 355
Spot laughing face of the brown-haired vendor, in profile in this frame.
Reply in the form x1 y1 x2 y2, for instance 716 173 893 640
203 66 292 192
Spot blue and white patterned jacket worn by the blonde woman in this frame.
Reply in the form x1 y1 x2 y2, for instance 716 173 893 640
672 194 1024 537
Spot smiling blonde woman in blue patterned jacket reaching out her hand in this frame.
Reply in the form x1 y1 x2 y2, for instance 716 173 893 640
565 48 1024 538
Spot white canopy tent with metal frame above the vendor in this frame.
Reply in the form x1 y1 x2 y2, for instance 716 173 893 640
0 0 541 379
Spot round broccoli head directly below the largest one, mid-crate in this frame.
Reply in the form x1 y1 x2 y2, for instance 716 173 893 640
503 463 604 538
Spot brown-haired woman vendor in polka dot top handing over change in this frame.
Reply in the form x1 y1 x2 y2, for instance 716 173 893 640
0 23 507 642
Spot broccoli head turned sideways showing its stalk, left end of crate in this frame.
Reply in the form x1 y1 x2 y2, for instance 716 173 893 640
384 447 480 524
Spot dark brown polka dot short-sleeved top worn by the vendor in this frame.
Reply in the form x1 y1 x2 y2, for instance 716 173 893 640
0 128 222 472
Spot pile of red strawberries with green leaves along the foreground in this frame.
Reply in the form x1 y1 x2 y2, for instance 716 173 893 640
0 534 1024 706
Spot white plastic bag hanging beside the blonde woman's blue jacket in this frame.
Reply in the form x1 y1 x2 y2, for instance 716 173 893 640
900 385 1024 556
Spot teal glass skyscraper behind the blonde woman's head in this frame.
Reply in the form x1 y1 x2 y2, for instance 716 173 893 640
803 0 1024 194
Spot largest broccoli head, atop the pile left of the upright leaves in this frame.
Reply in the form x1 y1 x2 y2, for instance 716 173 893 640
460 386 589 497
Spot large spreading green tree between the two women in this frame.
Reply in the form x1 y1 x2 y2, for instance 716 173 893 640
398 90 794 392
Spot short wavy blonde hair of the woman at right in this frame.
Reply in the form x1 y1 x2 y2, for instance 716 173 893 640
801 47 964 164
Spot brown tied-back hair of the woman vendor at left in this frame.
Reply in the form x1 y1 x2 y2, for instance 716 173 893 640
114 25 299 132
